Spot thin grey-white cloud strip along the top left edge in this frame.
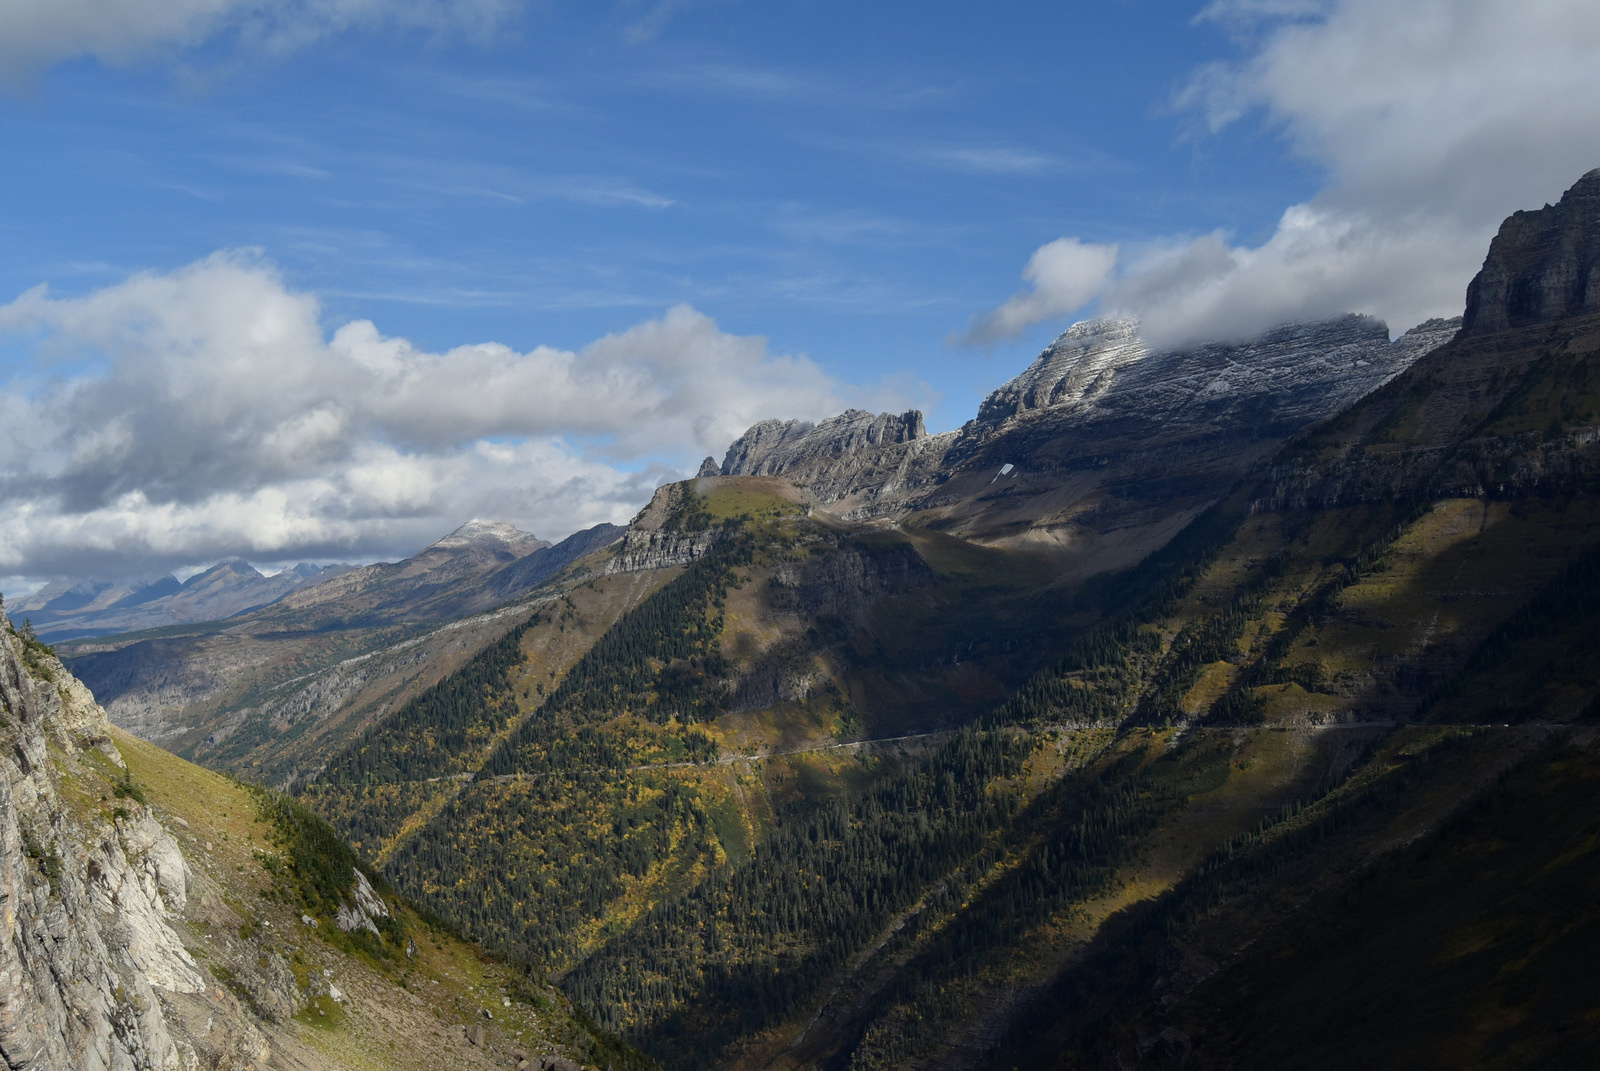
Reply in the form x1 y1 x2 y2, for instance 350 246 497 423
0 0 517 78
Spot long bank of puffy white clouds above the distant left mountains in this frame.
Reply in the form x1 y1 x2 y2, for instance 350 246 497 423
0 253 907 575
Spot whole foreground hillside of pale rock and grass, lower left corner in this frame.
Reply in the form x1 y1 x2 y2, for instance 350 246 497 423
0 601 626 1071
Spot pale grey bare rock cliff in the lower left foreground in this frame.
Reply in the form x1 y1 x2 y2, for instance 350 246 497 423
0 615 267 1071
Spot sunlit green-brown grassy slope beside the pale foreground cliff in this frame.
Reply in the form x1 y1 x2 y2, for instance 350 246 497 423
108 730 645 1069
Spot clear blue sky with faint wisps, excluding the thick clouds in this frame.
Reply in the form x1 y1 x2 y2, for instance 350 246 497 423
0 2 1317 427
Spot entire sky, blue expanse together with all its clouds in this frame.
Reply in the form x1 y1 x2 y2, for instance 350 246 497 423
0 0 1600 588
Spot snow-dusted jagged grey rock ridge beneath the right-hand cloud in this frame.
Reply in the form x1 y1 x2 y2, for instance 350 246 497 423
723 315 1458 540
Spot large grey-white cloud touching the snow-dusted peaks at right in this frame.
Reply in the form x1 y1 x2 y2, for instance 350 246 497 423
966 0 1600 344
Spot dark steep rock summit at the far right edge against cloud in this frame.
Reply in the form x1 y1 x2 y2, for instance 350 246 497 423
1461 168 1600 336
